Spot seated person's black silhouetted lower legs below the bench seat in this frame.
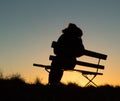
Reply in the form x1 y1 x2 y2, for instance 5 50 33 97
49 69 63 85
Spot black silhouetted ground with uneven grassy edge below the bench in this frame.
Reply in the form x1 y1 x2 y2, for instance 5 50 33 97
0 78 120 101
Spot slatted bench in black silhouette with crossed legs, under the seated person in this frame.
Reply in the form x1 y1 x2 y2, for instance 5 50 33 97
33 42 107 86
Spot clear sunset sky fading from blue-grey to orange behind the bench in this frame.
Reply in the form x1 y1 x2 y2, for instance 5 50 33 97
0 0 120 85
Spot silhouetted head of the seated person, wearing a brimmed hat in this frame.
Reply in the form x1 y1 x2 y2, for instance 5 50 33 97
62 23 83 37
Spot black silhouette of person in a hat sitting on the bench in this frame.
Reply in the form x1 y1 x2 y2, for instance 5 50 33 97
49 23 84 85
